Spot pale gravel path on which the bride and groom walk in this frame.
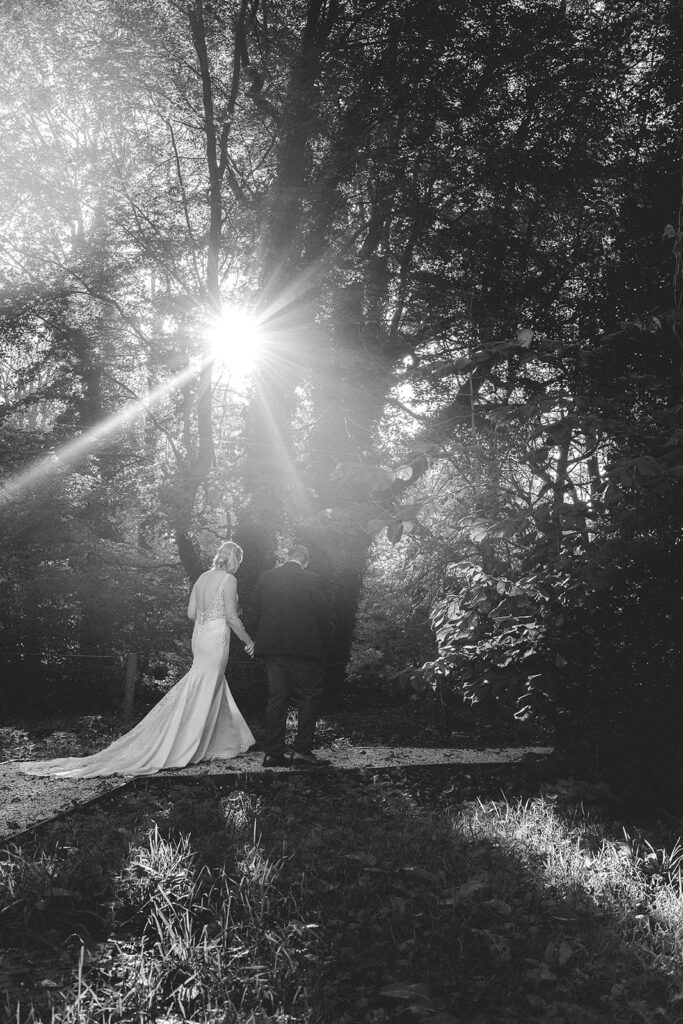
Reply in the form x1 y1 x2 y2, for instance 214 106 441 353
0 742 553 841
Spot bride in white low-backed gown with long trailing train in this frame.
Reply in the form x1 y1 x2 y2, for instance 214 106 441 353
18 541 254 778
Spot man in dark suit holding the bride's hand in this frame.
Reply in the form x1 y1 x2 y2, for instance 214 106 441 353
253 544 330 768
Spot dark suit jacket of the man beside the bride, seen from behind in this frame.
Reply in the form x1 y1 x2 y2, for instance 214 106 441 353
252 561 330 660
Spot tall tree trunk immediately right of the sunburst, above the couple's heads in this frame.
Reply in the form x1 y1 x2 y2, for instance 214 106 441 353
238 0 338 577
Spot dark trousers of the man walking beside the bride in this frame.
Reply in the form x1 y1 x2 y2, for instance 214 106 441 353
265 657 323 757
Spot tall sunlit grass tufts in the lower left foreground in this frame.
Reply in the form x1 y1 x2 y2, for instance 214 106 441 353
0 800 313 1024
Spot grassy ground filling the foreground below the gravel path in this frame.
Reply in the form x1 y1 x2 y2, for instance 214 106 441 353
0 769 683 1024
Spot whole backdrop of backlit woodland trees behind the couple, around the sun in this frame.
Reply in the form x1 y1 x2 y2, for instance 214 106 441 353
0 0 683 782
